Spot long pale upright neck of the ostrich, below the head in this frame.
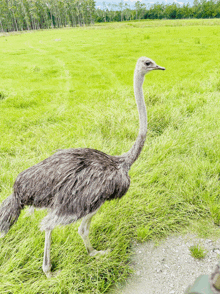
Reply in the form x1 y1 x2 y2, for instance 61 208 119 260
124 68 147 167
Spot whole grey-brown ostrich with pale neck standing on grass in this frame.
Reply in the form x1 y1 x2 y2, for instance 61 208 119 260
0 57 165 278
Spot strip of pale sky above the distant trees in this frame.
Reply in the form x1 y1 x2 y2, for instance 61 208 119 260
96 0 193 8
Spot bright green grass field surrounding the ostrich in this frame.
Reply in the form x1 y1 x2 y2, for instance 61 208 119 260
0 20 220 294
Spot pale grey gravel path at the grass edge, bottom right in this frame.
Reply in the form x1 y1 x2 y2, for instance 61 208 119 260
113 235 220 294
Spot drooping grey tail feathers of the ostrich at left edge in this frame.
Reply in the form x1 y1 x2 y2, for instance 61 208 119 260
0 194 22 237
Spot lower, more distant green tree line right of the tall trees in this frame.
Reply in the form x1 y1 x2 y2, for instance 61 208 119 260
95 0 220 22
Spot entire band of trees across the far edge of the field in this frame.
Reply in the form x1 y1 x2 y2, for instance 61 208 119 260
0 0 220 32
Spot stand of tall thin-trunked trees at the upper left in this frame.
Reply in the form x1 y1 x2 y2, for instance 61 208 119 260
0 0 95 32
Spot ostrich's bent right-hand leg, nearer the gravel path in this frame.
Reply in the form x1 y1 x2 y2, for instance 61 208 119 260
78 209 109 256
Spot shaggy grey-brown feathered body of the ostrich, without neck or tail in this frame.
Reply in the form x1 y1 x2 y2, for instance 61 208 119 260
4 148 130 230
